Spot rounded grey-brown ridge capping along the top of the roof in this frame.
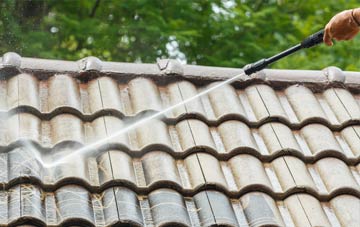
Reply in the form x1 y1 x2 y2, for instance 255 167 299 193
0 52 360 90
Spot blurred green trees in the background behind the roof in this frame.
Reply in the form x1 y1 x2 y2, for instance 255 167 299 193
0 0 360 71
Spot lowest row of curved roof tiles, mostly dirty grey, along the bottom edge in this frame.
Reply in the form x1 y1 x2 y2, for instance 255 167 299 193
0 184 360 226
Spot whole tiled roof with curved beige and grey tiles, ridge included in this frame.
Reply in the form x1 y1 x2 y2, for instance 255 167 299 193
0 53 360 227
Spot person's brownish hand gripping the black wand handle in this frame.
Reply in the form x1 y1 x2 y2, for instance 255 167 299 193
324 8 360 46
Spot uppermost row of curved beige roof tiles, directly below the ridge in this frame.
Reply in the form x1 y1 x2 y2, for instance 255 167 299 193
1 74 359 128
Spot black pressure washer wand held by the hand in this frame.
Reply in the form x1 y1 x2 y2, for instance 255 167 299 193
244 30 324 76
